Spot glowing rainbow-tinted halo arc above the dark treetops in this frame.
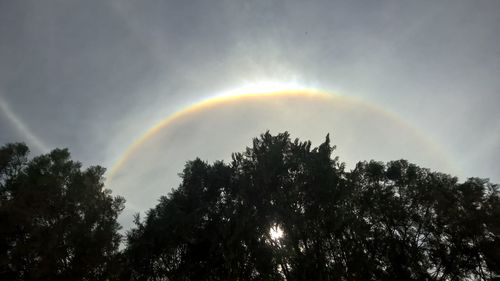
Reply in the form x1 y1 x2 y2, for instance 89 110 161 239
107 87 456 183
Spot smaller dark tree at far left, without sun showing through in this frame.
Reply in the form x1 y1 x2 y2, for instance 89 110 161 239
0 144 124 280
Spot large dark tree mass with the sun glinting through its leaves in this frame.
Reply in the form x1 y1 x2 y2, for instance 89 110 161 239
124 132 500 280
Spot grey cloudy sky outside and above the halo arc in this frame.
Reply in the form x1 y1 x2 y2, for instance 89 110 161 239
0 0 500 223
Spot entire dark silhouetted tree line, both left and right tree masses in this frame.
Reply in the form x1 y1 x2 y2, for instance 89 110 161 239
0 132 500 281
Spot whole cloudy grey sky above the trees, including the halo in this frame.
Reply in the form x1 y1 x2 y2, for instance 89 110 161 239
0 0 500 228
